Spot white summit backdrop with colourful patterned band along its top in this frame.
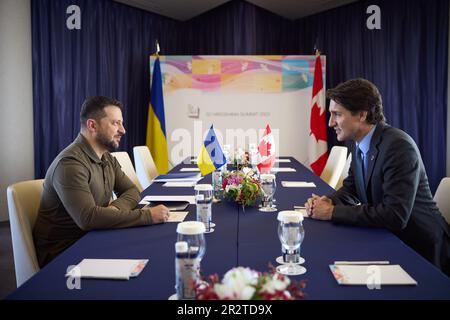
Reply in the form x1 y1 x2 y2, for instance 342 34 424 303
151 56 325 164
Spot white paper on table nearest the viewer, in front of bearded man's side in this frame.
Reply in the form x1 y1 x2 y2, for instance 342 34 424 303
66 259 148 280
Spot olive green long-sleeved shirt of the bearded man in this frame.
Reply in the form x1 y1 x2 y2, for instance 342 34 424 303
33 134 152 267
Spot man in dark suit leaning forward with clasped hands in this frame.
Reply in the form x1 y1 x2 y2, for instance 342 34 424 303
305 79 450 275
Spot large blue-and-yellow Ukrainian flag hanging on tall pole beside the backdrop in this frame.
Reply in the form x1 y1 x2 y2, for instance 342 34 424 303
147 57 169 174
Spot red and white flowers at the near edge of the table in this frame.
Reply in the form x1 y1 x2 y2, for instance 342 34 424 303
195 267 305 300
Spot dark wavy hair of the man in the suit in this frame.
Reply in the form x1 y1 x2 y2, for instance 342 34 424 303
327 78 386 124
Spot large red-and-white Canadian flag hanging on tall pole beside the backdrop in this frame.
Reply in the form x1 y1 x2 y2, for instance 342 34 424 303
308 54 328 176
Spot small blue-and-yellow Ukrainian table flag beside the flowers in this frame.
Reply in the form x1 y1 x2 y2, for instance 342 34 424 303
197 126 227 176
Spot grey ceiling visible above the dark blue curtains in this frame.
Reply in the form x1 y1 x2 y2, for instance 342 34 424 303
114 0 356 21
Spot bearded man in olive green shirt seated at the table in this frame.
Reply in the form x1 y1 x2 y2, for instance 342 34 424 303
33 96 169 267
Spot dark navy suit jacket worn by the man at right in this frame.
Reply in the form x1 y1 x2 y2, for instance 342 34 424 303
330 123 450 275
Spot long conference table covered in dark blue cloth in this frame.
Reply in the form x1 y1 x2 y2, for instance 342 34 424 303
7 157 450 300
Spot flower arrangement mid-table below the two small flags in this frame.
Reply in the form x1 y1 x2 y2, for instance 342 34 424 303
222 168 261 206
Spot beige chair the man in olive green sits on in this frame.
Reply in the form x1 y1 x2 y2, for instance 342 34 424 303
6 180 44 287
